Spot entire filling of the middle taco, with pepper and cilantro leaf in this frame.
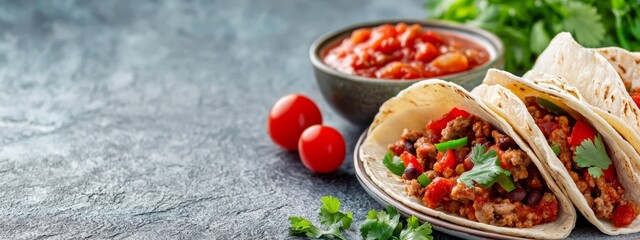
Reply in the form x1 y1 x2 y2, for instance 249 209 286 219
525 97 640 227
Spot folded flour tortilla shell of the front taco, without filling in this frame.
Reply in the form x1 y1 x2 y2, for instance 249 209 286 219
359 80 576 239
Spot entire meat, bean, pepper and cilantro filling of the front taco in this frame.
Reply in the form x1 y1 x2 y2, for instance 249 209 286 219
383 108 559 228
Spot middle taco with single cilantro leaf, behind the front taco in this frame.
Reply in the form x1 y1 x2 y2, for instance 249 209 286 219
473 69 640 235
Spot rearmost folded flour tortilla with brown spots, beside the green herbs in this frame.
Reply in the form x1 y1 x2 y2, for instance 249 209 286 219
524 33 640 173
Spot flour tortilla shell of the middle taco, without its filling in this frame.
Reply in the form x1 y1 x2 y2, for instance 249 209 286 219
472 69 640 235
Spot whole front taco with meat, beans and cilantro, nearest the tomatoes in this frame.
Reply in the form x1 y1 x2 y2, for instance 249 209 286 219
359 80 576 239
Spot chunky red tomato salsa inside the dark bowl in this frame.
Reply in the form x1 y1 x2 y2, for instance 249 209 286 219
323 23 489 79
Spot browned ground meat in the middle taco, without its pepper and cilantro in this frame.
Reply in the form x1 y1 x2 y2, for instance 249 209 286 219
525 97 638 223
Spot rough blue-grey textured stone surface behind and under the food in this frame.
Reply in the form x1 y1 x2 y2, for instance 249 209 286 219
0 0 632 239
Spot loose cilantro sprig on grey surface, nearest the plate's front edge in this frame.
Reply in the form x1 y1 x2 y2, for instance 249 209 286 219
360 206 433 240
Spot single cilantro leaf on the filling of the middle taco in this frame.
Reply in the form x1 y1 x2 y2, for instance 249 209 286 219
573 134 611 178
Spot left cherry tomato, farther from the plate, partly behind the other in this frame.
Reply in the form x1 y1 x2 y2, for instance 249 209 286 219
267 94 322 151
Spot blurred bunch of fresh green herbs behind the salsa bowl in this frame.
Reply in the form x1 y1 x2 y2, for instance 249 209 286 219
426 0 640 72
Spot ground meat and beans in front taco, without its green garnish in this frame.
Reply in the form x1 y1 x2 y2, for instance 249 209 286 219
389 112 558 228
